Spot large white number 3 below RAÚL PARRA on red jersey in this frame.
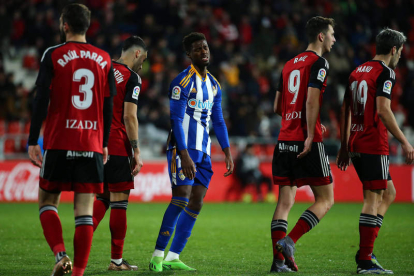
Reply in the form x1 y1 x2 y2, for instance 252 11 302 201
72 69 95 110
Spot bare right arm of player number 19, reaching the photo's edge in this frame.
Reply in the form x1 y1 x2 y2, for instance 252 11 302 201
376 96 414 164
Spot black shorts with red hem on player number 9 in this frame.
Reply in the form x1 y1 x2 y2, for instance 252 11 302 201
272 141 332 187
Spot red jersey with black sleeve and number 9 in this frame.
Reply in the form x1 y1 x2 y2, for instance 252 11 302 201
278 51 329 142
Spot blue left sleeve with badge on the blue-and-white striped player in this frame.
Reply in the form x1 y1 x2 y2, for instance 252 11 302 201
168 78 190 150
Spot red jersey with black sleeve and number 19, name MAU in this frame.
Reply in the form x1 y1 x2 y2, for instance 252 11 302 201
345 60 395 155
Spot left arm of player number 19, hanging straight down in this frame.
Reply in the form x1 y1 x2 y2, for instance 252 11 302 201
336 92 351 171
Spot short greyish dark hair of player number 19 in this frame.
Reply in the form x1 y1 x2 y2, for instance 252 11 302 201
375 28 407 55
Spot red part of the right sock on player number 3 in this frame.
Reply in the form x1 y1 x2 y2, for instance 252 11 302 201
72 225 93 276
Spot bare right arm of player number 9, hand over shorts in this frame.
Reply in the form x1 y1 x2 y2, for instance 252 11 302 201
298 87 321 159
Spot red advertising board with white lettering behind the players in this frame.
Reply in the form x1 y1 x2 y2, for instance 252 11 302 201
0 161 414 202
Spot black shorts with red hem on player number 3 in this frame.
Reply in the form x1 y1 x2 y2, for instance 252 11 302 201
39 150 103 193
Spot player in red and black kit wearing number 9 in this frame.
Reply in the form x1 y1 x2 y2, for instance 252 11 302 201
270 16 336 272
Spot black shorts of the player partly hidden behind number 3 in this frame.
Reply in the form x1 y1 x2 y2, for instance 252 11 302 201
104 155 134 192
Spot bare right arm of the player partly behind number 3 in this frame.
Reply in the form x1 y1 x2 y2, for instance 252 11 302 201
124 102 144 176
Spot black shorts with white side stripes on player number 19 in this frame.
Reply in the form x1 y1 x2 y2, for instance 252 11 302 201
349 152 391 190
